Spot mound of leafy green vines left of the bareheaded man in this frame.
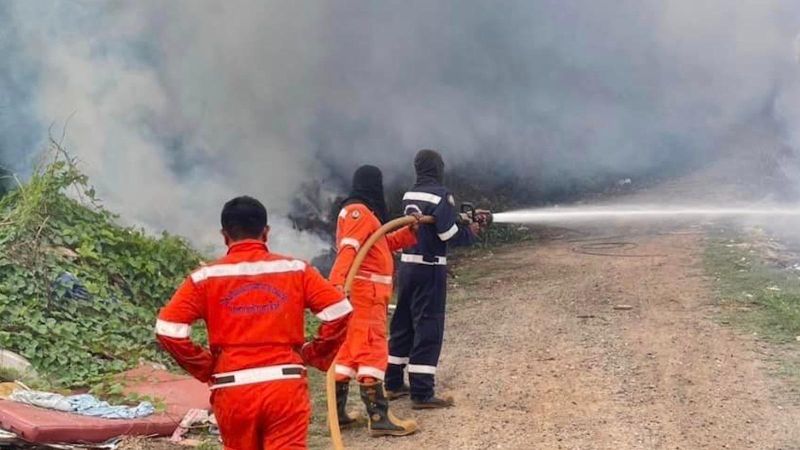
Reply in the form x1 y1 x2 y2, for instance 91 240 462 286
0 143 201 387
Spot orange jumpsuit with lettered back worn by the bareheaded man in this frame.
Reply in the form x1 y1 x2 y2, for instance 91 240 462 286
156 240 352 450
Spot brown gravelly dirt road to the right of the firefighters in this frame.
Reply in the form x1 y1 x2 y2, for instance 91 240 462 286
345 232 800 450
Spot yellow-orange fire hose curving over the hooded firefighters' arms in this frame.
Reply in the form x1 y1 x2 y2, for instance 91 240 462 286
325 216 434 450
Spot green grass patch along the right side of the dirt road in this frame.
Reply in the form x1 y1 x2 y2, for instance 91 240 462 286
705 233 800 343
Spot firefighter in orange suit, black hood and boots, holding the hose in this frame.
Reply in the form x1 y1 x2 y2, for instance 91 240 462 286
330 166 417 436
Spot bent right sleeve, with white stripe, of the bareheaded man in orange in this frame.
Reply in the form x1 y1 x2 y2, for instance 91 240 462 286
300 266 353 371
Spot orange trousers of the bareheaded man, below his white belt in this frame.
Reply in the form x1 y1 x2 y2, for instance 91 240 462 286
211 378 311 450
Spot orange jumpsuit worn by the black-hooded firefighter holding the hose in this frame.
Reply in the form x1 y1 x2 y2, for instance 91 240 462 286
330 203 417 381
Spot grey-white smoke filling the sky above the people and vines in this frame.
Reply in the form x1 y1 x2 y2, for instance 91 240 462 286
0 0 800 256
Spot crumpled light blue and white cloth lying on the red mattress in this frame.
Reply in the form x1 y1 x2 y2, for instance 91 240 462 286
9 390 155 419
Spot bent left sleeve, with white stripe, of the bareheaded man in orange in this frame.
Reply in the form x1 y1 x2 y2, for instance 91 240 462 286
156 278 214 383
